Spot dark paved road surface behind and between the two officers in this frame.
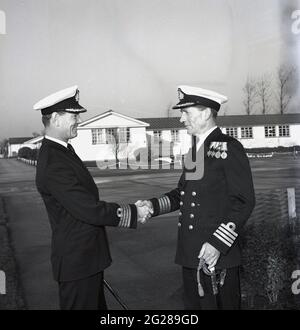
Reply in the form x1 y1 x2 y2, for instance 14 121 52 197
0 158 300 309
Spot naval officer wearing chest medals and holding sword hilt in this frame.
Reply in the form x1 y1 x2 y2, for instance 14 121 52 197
139 86 255 309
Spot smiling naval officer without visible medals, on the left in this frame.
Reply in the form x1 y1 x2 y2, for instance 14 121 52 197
34 86 150 310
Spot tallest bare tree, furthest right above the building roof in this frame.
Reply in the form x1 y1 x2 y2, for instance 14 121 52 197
277 65 296 114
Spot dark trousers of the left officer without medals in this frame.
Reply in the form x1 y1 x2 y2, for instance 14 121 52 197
58 272 107 310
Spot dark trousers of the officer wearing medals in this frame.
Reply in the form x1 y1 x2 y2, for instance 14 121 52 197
182 267 241 310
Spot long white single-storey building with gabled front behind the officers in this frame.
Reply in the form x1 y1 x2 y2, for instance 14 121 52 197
10 110 300 161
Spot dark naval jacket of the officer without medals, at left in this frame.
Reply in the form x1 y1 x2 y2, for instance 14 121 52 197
36 139 137 281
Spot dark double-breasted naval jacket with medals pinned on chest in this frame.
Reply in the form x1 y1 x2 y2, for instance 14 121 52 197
151 128 255 269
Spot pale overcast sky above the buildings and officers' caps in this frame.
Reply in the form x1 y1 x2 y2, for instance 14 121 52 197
0 0 300 139
